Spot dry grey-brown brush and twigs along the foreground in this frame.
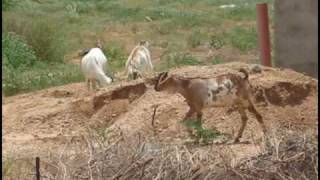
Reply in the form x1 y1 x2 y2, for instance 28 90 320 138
3 129 318 180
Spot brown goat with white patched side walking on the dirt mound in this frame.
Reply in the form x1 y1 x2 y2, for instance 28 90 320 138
154 69 266 143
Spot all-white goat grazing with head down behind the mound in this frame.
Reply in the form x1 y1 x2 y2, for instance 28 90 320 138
81 48 113 90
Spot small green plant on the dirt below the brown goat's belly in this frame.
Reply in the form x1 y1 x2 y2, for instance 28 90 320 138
182 119 221 144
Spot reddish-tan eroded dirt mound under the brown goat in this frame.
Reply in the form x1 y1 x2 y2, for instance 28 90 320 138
3 63 318 158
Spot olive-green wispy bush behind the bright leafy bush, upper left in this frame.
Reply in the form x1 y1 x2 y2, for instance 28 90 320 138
3 13 67 62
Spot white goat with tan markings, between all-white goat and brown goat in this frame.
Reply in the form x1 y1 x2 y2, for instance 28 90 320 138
125 41 153 79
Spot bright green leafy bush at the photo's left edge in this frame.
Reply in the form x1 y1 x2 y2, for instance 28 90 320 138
2 33 36 68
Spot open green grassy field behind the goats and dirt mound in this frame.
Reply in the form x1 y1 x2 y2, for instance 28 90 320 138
2 0 273 95
